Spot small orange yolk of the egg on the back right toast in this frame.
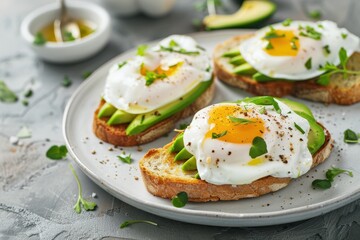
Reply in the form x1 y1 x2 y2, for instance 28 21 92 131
264 30 300 56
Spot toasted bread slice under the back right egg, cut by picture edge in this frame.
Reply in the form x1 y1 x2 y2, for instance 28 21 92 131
213 34 360 105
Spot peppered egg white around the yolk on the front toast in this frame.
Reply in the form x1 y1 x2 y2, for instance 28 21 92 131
184 100 312 185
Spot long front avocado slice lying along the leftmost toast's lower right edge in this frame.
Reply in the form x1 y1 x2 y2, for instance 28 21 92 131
126 79 213 135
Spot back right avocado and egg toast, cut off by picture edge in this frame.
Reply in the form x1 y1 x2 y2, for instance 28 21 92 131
213 19 360 105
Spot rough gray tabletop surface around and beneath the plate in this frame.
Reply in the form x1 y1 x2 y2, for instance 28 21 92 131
0 0 360 240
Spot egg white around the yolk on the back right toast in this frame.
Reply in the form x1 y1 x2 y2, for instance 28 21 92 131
239 21 360 80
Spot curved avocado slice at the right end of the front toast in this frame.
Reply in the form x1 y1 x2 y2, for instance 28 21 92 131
296 112 325 154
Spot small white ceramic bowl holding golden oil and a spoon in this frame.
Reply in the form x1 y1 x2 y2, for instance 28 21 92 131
20 1 111 63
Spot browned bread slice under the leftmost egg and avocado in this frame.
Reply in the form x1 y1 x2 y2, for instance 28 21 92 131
93 81 215 146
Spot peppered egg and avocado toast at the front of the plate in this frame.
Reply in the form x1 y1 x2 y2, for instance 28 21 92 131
139 96 333 202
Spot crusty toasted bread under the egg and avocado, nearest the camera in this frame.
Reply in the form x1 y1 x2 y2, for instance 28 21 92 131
139 124 333 202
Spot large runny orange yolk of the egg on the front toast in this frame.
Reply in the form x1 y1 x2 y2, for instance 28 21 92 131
205 105 265 144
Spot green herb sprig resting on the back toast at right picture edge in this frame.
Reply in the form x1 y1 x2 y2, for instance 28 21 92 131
316 48 360 85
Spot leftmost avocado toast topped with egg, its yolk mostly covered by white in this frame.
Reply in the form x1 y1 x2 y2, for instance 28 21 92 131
93 35 215 146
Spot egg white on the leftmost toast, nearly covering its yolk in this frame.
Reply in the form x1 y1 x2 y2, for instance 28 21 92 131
103 35 212 114
